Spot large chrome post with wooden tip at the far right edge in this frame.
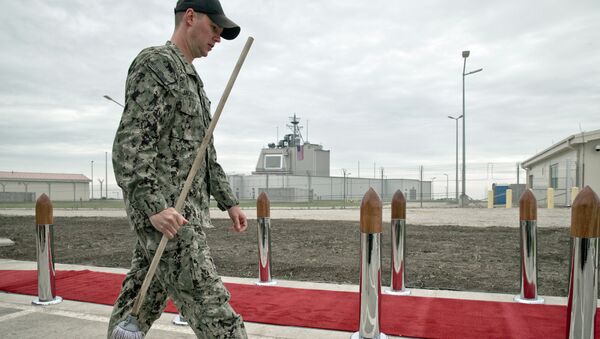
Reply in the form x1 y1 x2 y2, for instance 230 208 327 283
566 186 600 338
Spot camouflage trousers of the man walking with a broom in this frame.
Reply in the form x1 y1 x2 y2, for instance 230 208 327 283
108 225 247 338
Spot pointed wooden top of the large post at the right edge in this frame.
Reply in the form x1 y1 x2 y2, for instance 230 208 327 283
571 186 600 238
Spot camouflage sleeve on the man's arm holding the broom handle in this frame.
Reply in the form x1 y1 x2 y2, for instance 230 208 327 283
113 55 168 216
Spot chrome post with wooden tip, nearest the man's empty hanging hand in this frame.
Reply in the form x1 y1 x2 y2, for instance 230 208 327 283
256 192 277 286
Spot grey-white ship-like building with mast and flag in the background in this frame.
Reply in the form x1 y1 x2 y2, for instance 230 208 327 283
229 114 432 202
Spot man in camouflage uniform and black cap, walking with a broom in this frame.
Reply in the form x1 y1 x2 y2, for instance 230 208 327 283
108 0 247 338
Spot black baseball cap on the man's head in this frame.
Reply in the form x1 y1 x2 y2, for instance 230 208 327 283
175 0 240 40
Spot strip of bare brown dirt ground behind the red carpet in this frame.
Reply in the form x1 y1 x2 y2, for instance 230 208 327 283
0 216 570 296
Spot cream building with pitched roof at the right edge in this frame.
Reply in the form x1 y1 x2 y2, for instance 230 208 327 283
521 130 600 206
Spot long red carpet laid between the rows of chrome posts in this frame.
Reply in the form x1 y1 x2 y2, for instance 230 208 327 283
0 270 600 339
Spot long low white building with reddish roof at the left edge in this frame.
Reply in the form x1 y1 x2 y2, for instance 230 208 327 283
0 171 90 202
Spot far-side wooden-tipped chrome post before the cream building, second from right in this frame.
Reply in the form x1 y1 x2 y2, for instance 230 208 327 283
514 189 544 304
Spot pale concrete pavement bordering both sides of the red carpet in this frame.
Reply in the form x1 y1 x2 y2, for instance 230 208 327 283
0 259 567 339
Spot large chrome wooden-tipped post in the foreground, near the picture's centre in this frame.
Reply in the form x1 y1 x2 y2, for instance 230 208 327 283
350 188 387 339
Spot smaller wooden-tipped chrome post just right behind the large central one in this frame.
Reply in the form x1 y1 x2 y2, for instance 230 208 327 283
383 190 410 295
